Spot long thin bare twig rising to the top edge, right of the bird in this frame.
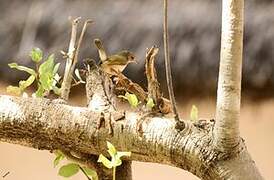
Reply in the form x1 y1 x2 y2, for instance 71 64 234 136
163 0 182 127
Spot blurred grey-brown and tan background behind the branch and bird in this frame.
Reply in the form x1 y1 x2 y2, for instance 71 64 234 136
0 0 274 180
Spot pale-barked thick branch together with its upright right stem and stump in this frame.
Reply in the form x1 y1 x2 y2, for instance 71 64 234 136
0 0 263 180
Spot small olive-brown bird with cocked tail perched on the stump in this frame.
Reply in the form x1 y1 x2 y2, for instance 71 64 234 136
94 39 137 76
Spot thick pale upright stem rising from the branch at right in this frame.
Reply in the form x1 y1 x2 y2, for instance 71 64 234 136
213 0 244 151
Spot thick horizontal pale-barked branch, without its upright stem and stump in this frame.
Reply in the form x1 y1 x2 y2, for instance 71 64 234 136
0 96 261 180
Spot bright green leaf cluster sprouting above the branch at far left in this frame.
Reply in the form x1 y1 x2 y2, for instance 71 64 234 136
7 48 60 97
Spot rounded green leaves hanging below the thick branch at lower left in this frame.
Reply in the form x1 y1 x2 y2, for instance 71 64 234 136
53 150 98 180
